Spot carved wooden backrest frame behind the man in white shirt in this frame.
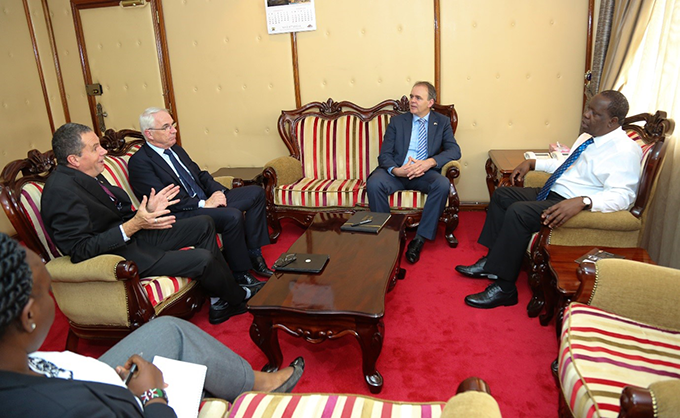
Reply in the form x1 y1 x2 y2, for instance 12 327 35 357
623 110 675 218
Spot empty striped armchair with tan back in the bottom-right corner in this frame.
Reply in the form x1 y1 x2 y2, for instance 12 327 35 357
558 259 680 418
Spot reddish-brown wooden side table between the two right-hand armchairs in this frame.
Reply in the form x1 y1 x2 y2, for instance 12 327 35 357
540 244 654 339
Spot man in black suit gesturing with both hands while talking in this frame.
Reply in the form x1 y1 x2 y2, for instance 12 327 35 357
41 123 259 324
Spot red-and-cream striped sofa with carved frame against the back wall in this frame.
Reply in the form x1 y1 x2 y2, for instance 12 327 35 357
263 96 460 247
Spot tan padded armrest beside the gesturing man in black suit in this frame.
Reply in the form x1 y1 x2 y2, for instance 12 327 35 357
45 254 137 283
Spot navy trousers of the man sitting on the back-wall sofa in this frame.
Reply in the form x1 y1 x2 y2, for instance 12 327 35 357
366 167 451 240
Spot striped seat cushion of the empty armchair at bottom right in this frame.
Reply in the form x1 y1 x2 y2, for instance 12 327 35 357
559 303 680 417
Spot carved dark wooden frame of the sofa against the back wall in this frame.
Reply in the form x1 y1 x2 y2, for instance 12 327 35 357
263 96 460 247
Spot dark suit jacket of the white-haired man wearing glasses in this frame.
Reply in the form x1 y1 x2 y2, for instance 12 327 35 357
128 144 227 212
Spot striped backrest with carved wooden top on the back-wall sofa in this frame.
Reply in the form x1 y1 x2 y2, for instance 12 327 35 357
278 96 458 180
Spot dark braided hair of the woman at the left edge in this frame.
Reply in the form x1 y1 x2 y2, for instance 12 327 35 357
0 232 33 337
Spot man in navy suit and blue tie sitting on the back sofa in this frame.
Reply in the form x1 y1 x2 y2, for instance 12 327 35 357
366 81 460 263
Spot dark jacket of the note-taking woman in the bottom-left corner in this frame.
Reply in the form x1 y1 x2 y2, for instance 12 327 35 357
0 371 177 418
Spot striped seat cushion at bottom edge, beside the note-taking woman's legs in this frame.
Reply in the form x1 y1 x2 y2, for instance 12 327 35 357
229 392 444 418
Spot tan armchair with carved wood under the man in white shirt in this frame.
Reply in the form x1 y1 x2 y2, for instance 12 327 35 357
524 110 675 325
